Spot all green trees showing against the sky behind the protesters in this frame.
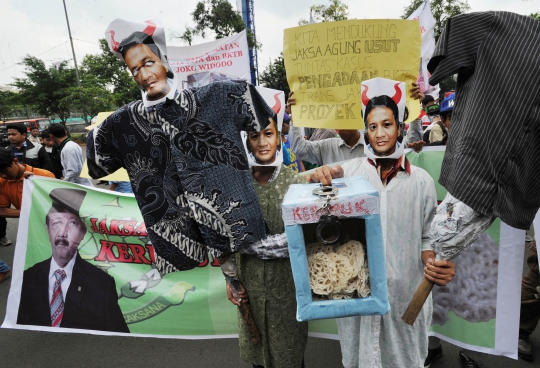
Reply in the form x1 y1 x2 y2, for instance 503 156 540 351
4 0 540 124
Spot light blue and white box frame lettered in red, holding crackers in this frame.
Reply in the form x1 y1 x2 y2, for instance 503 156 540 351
282 176 390 322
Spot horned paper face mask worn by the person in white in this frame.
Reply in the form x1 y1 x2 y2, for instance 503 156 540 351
362 78 406 159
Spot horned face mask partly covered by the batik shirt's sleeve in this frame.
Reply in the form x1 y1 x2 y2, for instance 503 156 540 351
240 86 285 166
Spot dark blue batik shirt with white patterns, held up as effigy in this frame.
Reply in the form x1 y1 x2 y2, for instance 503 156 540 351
87 81 273 273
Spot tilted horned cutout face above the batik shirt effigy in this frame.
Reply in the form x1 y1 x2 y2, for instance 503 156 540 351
105 19 178 106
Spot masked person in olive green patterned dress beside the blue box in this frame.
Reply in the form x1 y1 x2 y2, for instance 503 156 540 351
227 113 308 367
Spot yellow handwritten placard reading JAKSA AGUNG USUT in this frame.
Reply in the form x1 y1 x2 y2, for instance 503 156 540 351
283 19 420 129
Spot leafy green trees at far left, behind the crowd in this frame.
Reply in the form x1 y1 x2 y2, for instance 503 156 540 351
0 39 140 124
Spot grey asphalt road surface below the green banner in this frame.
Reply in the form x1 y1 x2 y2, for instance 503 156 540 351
0 186 540 368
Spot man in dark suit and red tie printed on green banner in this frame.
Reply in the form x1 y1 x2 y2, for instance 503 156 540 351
17 188 129 333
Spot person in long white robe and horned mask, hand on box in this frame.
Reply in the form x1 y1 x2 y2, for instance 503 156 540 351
310 78 454 368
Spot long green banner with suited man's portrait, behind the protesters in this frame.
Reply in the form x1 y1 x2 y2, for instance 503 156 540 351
2 151 523 357
